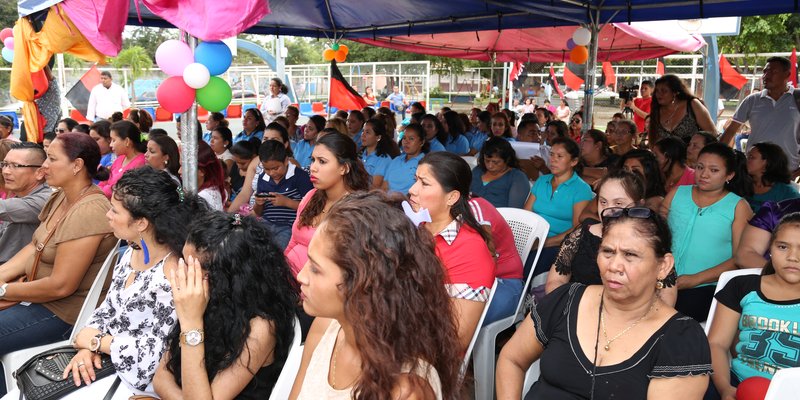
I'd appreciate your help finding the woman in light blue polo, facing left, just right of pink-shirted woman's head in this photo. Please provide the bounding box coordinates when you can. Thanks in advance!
[361,118,400,188]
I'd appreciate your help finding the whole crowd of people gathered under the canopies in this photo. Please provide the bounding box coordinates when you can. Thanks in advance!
[0,57,800,400]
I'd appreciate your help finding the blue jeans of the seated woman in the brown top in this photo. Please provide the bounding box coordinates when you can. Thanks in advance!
[0,304,72,394]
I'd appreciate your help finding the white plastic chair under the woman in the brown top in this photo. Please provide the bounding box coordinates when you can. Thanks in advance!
[0,241,119,390]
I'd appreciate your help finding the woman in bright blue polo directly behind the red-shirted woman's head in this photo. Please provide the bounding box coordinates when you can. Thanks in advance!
[383,124,428,194]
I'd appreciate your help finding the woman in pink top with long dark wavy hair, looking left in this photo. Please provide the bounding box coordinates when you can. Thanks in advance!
[284,133,370,275]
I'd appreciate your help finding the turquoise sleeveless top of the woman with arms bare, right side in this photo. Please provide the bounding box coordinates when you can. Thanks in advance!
[667,185,742,286]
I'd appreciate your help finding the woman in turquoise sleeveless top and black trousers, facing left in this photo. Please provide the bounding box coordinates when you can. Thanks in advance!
[661,143,753,322]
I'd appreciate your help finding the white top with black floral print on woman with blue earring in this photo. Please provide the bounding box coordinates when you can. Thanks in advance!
[87,248,178,395]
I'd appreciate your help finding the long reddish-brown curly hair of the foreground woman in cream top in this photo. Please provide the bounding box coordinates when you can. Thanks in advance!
[320,192,461,399]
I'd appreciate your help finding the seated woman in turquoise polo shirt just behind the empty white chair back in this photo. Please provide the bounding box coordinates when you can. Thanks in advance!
[524,138,594,276]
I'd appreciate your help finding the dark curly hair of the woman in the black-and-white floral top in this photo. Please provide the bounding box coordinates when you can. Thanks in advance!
[113,165,208,255]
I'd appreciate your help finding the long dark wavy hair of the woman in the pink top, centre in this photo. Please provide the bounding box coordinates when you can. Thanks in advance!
[299,132,372,227]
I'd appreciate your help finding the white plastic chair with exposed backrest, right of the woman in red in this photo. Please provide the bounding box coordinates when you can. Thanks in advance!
[472,207,550,399]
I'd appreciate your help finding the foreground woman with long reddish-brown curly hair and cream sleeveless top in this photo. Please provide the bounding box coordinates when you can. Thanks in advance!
[289,192,461,399]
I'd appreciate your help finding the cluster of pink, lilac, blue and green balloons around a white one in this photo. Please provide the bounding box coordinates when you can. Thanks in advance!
[156,40,233,113]
